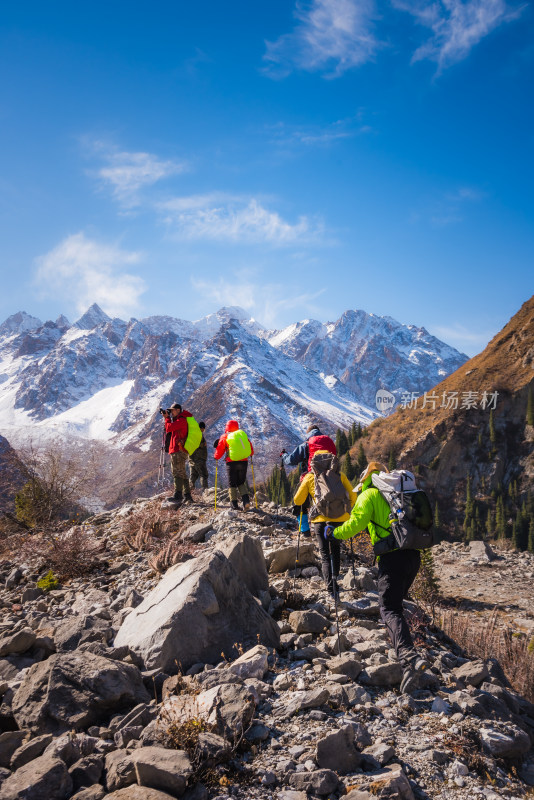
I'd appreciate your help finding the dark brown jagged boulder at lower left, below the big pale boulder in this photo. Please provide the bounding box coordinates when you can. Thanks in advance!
[13,652,150,734]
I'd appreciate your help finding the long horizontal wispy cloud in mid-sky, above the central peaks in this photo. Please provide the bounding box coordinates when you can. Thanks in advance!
[158,193,322,245]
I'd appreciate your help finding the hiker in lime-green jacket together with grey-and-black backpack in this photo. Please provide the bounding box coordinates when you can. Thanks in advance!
[332,461,433,692]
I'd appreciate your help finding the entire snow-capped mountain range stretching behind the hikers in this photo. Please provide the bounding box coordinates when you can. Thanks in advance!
[0,305,466,496]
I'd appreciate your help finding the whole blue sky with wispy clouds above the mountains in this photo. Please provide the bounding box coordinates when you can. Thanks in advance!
[0,0,534,355]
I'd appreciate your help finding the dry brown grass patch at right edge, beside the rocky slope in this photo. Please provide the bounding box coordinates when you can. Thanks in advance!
[439,609,534,702]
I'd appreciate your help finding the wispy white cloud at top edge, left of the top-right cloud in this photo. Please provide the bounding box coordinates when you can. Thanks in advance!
[264,0,379,77]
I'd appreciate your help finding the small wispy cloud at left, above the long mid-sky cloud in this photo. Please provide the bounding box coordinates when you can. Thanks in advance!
[92,142,187,208]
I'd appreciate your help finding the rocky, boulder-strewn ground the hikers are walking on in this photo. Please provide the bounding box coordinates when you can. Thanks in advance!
[0,492,534,800]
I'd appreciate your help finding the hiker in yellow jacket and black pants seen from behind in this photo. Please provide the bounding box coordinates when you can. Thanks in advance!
[293,450,356,599]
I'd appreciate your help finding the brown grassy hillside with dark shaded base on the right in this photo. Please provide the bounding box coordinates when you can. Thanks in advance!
[352,297,534,536]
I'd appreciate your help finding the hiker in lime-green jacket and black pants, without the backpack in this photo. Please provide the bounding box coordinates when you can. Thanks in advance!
[328,461,428,692]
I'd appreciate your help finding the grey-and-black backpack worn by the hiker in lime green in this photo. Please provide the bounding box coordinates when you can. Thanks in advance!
[371,469,436,556]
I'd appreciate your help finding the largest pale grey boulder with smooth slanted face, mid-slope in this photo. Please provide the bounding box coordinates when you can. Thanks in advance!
[115,550,280,673]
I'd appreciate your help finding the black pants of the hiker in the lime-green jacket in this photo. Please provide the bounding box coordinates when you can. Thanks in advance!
[377,550,421,664]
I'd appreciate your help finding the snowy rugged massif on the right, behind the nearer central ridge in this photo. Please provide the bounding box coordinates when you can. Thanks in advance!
[268,311,467,406]
